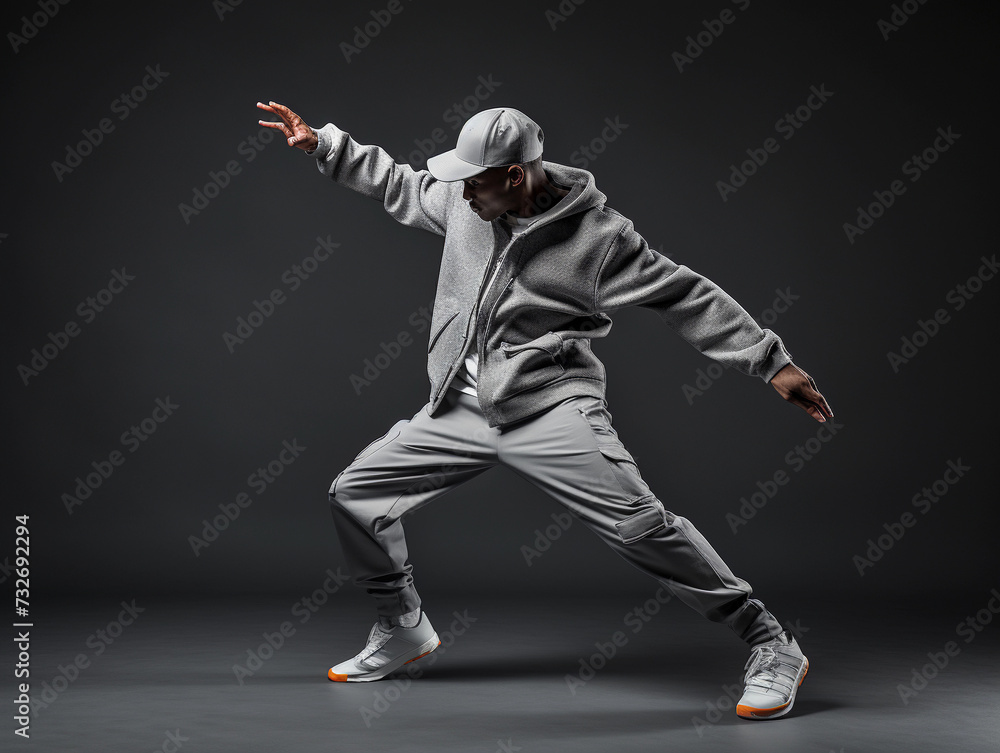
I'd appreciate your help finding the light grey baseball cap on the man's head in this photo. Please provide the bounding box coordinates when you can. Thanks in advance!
[427,107,544,181]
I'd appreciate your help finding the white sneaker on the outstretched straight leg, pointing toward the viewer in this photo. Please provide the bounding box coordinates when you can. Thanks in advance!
[736,631,809,719]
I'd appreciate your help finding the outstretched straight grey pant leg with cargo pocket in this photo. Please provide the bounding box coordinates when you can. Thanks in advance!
[499,396,782,645]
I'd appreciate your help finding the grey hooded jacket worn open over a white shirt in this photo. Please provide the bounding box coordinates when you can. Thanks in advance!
[308,123,792,427]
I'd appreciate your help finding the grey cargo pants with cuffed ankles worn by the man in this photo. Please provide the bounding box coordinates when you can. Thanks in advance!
[330,388,782,645]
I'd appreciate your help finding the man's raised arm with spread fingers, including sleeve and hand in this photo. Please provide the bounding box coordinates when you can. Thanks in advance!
[257,102,455,235]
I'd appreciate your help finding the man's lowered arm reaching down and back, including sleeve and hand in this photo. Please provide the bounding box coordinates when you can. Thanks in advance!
[594,220,833,422]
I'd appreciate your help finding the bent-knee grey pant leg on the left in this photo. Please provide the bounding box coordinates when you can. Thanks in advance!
[329,390,498,617]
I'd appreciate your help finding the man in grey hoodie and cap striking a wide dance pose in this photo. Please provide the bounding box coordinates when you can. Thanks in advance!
[257,102,833,719]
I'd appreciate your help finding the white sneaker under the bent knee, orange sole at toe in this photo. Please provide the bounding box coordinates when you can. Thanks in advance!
[326,610,441,682]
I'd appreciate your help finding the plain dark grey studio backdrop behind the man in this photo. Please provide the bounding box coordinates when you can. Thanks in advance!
[0,0,1000,604]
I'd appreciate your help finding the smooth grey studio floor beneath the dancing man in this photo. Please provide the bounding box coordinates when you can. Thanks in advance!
[9,593,1000,753]
